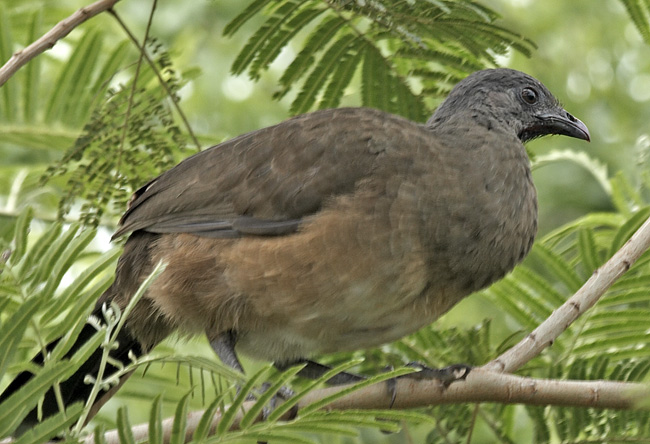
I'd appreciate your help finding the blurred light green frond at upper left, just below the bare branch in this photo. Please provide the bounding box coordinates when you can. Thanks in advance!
[0,16,129,150]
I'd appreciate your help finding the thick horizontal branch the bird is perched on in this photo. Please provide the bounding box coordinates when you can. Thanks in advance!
[90,368,650,444]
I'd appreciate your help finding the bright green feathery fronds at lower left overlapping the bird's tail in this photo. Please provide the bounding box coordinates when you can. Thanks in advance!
[0,210,118,442]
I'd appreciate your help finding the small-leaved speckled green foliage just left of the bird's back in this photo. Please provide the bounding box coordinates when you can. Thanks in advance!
[43,39,190,225]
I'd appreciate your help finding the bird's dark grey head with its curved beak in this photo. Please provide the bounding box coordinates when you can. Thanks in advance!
[427,68,590,142]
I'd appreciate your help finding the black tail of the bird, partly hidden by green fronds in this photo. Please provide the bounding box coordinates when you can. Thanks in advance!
[0,289,144,436]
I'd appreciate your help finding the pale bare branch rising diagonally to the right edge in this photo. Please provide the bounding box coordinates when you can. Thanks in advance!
[483,215,650,373]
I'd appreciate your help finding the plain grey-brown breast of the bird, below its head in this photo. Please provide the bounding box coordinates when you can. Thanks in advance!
[422,138,537,293]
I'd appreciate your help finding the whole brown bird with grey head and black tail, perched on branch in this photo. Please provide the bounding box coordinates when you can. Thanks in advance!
[2,68,590,427]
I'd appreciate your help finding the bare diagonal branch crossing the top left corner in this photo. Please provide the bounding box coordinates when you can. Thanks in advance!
[0,0,119,86]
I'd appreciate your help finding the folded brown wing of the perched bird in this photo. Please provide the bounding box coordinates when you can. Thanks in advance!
[114,108,417,237]
